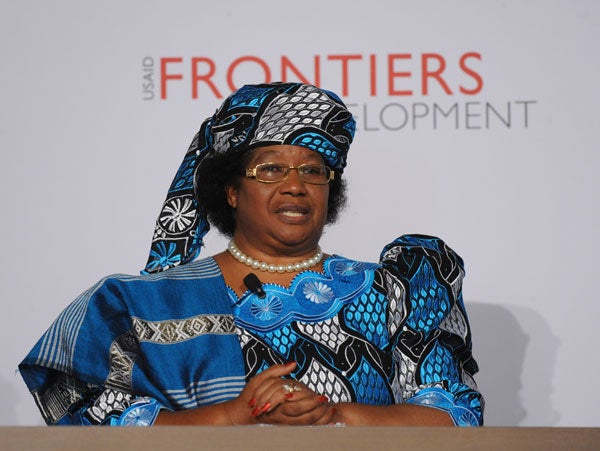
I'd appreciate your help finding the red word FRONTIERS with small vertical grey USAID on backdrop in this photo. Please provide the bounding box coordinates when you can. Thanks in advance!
[142,52,484,100]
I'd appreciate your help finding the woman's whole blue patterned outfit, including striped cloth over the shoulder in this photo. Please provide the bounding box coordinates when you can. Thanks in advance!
[20,235,483,426]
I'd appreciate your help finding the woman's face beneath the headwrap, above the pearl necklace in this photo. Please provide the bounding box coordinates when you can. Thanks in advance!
[227,145,329,258]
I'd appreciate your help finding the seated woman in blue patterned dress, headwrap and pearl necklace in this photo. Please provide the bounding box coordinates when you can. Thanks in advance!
[20,83,483,425]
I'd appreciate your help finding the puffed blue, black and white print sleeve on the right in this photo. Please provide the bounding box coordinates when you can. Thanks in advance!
[380,235,484,426]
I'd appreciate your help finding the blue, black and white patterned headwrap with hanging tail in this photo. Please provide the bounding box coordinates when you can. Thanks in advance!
[142,83,356,273]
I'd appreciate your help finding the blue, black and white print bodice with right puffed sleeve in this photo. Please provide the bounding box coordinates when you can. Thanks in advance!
[229,235,483,426]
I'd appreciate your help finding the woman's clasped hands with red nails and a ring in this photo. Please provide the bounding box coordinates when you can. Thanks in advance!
[229,362,336,425]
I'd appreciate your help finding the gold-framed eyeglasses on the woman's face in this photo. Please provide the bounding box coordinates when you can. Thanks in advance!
[245,163,335,185]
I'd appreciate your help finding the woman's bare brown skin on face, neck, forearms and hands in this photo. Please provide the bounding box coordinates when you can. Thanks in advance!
[155,145,453,426]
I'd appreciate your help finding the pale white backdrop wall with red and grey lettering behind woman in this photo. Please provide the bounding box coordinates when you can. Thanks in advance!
[0,0,600,426]
